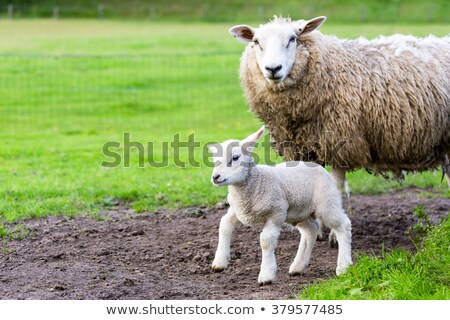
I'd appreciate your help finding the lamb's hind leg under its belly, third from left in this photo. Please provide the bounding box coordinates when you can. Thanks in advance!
[289,219,318,276]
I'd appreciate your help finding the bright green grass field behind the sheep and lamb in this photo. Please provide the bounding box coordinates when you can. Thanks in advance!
[0,20,448,221]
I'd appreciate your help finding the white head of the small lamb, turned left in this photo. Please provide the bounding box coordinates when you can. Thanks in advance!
[208,126,264,187]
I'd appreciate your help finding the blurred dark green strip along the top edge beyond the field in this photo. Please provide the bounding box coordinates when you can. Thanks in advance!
[0,1,450,23]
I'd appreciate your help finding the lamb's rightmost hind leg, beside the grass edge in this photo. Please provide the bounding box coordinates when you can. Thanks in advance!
[330,210,352,275]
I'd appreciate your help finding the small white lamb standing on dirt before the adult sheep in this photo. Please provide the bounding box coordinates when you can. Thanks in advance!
[209,127,352,285]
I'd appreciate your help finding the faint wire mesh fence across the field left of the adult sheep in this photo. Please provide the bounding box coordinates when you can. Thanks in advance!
[0,52,243,132]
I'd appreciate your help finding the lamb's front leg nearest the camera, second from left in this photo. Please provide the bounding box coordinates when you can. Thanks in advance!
[258,220,281,285]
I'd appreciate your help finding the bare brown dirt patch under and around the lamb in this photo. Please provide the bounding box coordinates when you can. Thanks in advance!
[0,190,450,299]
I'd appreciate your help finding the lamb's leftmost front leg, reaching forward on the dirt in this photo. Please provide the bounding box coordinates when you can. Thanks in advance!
[212,207,238,272]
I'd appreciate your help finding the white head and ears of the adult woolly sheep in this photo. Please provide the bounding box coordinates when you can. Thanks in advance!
[229,17,326,84]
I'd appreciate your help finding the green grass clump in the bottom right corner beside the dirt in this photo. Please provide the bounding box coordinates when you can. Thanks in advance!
[298,216,450,300]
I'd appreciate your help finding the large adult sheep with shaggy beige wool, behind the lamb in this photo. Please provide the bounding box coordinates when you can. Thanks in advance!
[230,17,450,190]
